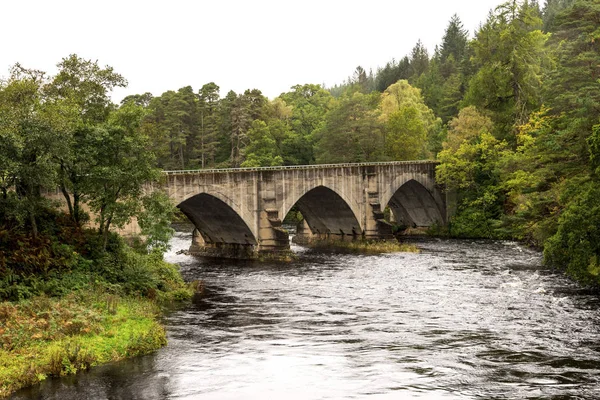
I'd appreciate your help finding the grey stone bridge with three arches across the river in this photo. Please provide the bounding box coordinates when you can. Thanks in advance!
[149,161,446,258]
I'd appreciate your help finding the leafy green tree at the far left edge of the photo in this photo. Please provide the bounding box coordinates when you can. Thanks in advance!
[0,69,72,238]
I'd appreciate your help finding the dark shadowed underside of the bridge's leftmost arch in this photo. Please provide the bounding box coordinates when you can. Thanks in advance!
[177,193,258,245]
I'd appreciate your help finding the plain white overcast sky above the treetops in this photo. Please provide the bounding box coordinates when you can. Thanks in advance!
[0,0,503,101]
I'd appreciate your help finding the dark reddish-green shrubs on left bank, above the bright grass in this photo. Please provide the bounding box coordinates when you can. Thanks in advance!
[0,205,189,300]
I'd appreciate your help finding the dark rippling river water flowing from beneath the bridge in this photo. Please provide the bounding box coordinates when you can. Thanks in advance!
[14,233,600,400]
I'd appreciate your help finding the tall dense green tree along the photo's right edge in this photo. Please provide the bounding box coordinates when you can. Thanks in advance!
[504,0,600,247]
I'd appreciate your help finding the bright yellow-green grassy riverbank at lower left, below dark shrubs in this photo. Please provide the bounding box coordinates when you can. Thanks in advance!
[0,290,175,398]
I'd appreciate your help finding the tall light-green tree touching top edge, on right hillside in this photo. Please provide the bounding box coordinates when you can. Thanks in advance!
[466,0,549,142]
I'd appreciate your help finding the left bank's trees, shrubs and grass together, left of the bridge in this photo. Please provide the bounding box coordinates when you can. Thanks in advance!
[0,57,192,397]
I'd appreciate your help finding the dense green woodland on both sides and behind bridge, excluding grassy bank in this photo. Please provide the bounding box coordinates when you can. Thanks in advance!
[0,0,600,284]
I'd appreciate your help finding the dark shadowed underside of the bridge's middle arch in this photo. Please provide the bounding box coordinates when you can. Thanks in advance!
[294,186,362,237]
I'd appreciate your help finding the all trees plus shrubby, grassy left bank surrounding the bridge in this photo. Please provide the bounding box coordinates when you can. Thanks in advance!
[0,0,600,394]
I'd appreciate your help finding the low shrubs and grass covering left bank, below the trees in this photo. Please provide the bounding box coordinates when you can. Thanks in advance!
[0,219,193,398]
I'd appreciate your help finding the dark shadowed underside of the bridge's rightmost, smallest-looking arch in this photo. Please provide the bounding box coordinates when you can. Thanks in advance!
[387,179,444,227]
